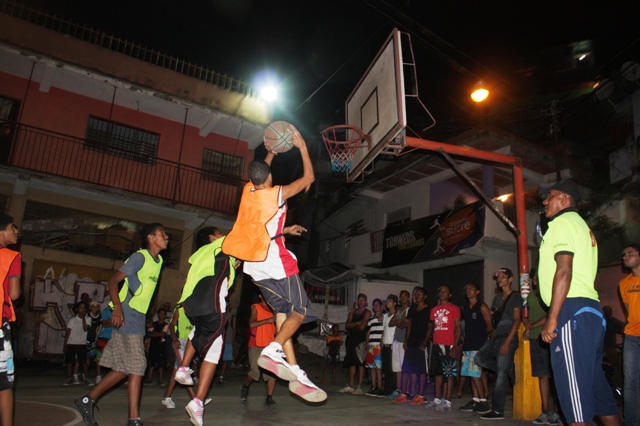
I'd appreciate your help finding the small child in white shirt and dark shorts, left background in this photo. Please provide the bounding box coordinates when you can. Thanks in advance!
[62,302,93,386]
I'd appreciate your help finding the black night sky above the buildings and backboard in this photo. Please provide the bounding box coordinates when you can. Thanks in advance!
[26,0,640,138]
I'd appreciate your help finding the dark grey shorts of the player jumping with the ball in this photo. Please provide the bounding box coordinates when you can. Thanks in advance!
[254,274,318,324]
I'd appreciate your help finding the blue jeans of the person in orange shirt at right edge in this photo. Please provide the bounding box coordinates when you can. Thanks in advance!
[623,334,640,426]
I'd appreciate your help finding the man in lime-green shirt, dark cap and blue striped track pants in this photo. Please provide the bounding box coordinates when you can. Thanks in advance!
[539,181,620,426]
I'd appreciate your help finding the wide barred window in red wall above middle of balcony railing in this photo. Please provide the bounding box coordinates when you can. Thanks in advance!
[85,117,160,164]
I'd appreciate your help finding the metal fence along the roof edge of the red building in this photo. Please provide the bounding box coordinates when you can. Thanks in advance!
[0,0,258,97]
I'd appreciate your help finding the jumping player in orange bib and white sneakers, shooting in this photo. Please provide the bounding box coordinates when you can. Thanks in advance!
[222,125,327,402]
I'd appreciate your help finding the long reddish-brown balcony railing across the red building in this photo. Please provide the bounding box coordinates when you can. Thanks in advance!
[0,122,245,215]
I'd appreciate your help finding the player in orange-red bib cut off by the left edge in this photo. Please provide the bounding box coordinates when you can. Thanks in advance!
[0,215,22,426]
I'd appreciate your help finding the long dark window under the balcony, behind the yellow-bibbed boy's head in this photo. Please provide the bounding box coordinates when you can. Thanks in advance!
[20,201,183,269]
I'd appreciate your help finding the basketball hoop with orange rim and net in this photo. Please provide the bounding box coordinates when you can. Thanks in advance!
[322,124,369,173]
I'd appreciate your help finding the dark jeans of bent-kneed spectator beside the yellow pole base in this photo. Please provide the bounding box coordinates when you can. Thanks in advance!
[474,336,518,414]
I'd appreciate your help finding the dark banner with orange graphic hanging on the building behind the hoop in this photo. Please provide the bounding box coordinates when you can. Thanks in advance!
[382,201,486,267]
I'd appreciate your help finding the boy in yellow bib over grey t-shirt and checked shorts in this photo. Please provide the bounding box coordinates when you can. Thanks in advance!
[74,223,169,426]
